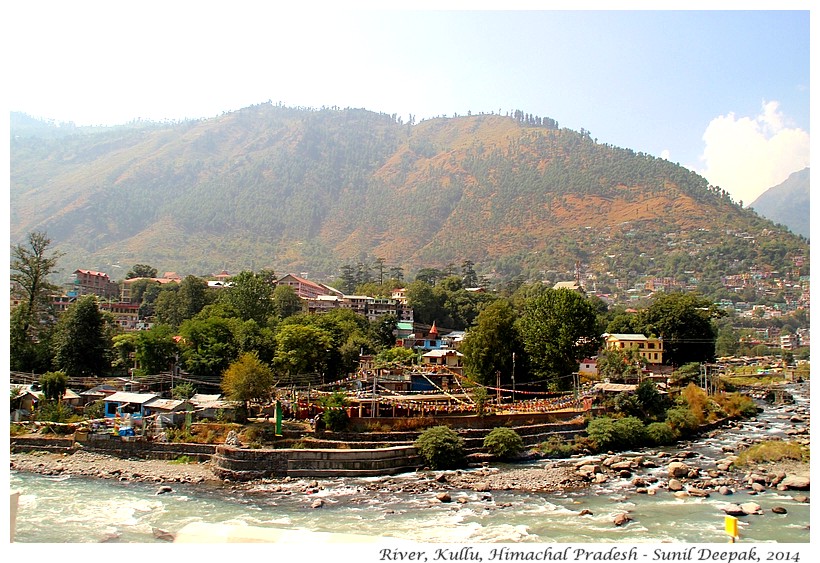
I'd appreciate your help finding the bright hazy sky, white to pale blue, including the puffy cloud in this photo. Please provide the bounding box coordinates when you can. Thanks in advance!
[2,0,810,204]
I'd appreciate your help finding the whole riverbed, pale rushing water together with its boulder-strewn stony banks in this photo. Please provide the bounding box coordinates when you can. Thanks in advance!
[10,383,810,543]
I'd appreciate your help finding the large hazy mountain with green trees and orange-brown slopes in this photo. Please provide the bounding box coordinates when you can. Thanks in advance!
[10,103,809,282]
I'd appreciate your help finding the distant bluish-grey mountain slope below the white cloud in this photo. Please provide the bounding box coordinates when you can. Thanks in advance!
[749,168,811,238]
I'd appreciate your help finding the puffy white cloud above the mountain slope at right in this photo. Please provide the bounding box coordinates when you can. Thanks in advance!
[690,101,810,206]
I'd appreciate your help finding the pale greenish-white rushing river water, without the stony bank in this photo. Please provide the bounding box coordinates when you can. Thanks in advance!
[10,384,810,543]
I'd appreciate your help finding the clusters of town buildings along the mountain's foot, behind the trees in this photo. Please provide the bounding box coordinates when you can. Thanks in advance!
[16,252,811,350]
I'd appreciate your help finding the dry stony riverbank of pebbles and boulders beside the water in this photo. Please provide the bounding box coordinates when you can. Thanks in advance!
[10,382,810,500]
